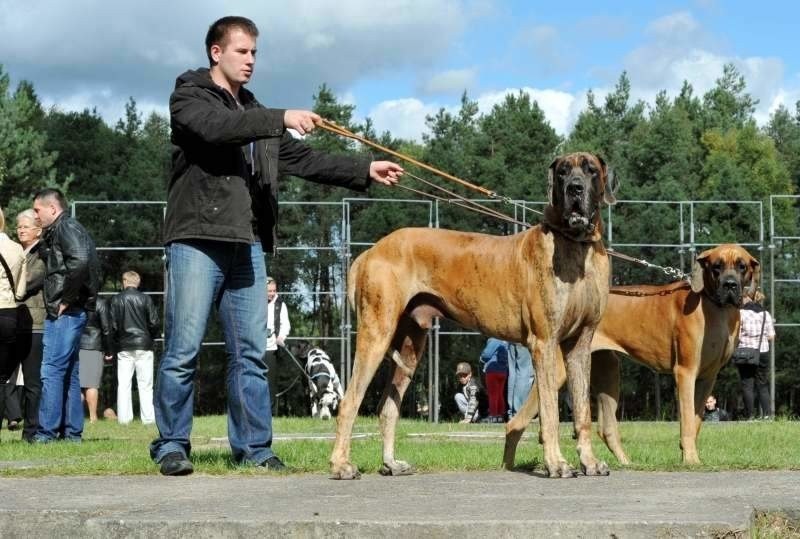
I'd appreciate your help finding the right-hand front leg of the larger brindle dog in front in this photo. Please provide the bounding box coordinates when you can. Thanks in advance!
[562,326,608,475]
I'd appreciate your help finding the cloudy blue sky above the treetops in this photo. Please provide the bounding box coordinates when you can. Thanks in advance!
[0,0,800,139]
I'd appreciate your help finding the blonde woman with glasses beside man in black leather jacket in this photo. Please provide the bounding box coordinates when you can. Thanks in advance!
[14,209,46,442]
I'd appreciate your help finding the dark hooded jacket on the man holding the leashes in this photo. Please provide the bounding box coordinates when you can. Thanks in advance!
[164,69,370,251]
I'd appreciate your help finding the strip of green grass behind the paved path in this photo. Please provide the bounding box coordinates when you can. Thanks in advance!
[0,416,800,477]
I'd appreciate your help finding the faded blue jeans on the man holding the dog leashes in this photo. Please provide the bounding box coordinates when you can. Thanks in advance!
[150,240,273,464]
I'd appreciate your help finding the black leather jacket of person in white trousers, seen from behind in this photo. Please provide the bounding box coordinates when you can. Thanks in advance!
[111,286,161,352]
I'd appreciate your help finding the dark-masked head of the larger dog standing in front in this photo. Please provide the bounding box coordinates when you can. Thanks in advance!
[545,152,617,241]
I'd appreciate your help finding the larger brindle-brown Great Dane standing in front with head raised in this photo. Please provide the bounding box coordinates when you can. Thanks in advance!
[330,153,615,479]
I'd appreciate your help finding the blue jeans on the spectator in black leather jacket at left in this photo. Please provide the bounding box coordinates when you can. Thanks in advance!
[34,311,86,442]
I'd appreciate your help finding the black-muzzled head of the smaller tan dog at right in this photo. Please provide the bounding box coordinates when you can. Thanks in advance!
[691,243,761,307]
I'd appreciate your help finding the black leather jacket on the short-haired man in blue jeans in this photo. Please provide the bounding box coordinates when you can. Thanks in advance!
[39,212,100,317]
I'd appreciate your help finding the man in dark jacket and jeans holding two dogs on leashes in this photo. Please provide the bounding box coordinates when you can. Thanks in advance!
[150,13,402,475]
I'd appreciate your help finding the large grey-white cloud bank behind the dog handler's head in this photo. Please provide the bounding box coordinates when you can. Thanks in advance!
[0,0,470,121]
